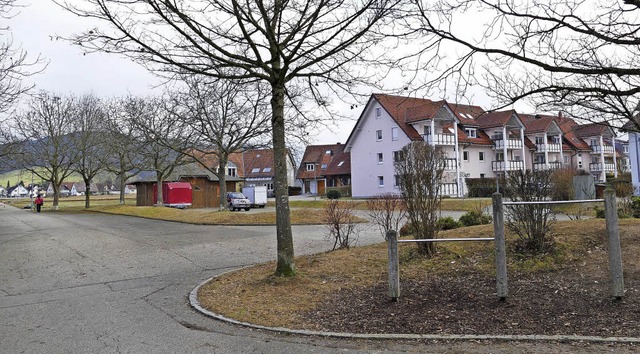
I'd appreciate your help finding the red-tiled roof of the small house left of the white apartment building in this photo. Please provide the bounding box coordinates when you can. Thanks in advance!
[296,144,351,179]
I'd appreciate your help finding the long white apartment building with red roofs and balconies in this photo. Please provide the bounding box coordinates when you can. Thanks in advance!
[344,94,632,197]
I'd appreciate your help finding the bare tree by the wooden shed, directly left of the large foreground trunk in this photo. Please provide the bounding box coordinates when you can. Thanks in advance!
[169,75,271,209]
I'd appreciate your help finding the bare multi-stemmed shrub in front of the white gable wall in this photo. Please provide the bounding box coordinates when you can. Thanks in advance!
[394,141,446,257]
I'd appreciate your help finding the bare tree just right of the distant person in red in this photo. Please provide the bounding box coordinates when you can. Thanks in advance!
[12,92,78,209]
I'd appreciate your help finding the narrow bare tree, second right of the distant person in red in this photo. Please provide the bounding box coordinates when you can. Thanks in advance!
[70,94,105,208]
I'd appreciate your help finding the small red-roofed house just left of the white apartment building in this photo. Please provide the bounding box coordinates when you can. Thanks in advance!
[296,143,352,195]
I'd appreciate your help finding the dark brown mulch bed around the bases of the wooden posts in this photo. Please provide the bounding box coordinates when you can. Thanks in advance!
[304,258,640,337]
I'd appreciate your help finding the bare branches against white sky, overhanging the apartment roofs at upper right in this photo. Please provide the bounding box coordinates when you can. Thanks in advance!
[407,0,640,129]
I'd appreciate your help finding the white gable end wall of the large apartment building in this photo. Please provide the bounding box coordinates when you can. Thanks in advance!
[350,100,411,198]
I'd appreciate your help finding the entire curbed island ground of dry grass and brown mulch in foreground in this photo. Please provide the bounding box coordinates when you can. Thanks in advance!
[199,219,640,337]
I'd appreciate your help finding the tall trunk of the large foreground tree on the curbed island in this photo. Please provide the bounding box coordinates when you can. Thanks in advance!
[271,80,295,277]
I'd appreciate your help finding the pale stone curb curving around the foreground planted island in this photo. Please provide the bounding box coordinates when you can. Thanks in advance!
[189,269,640,343]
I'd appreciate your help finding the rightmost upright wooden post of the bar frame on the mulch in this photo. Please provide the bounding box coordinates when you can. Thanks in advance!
[604,188,624,299]
